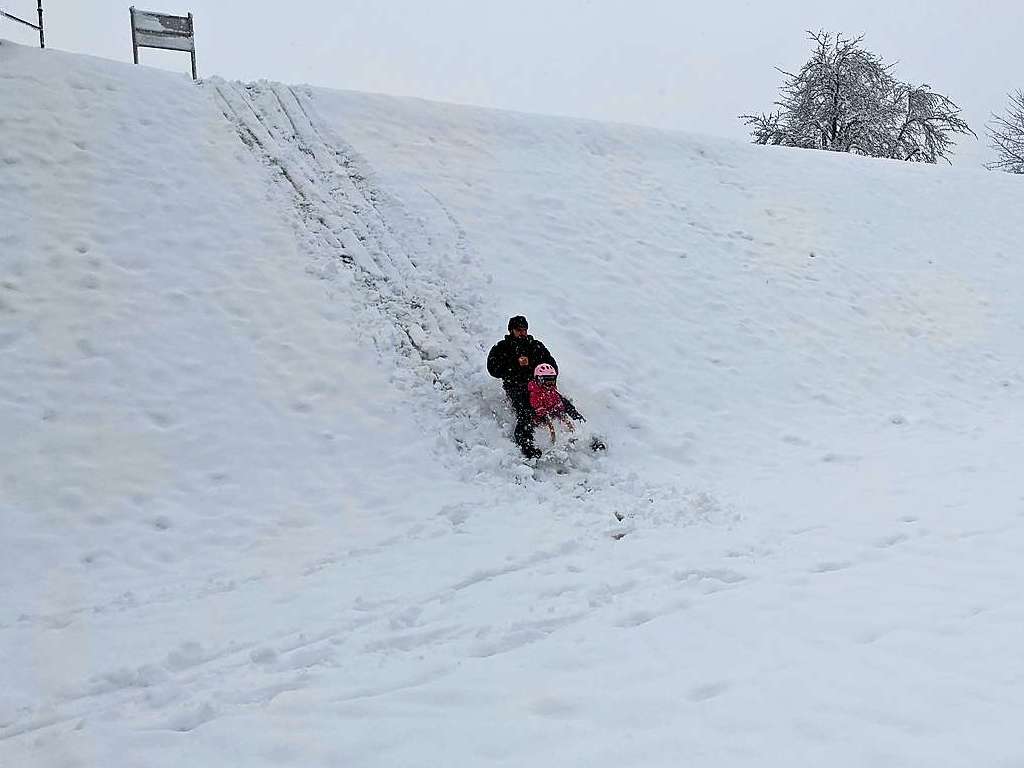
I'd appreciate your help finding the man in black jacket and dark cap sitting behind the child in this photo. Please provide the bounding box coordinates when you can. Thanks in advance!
[487,314,558,459]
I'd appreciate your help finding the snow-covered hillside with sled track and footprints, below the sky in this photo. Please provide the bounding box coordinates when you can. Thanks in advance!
[6,42,1024,768]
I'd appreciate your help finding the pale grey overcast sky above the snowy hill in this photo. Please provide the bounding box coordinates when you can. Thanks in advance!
[0,0,1024,164]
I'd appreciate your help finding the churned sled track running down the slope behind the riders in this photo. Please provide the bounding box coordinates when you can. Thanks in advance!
[212,80,497,460]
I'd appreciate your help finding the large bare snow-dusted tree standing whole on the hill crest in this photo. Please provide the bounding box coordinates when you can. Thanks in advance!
[741,32,974,163]
